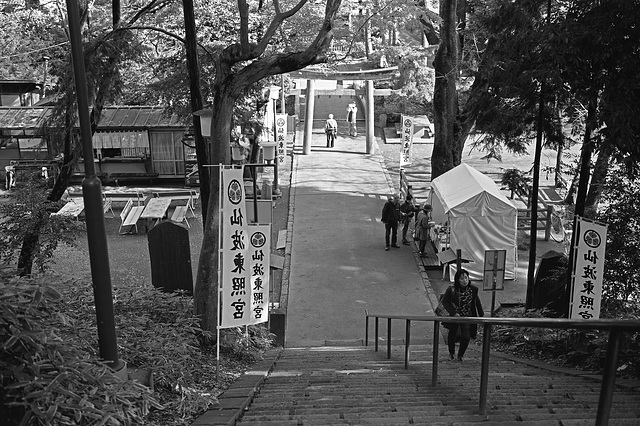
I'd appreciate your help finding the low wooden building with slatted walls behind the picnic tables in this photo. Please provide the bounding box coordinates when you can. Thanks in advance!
[0,106,195,183]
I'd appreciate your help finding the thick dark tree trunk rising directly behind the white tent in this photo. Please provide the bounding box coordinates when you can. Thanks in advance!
[431,1,462,180]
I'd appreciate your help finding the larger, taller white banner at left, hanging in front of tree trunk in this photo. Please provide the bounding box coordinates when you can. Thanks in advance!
[220,167,251,328]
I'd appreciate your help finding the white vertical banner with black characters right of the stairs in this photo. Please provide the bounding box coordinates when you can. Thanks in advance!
[569,216,607,320]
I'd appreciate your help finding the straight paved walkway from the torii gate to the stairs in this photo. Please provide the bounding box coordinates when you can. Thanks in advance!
[281,133,433,347]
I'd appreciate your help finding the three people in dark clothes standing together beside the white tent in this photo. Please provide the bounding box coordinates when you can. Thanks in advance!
[382,194,434,257]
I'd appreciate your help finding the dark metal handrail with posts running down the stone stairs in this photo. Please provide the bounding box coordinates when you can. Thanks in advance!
[365,310,640,426]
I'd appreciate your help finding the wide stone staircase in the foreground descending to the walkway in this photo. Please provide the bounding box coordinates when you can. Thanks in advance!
[228,343,640,426]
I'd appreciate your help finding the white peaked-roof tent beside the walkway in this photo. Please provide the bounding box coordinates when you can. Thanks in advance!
[431,163,518,281]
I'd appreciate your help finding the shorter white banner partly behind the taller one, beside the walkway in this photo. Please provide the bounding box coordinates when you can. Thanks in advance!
[249,224,271,324]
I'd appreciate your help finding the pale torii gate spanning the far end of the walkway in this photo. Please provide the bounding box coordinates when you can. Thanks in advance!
[290,67,398,155]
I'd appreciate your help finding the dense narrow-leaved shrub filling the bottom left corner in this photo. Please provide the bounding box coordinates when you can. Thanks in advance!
[0,269,160,425]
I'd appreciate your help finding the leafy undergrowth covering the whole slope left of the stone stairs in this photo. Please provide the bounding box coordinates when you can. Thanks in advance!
[0,269,270,426]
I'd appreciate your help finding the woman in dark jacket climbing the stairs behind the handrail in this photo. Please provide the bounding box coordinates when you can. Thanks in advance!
[442,269,484,362]
